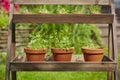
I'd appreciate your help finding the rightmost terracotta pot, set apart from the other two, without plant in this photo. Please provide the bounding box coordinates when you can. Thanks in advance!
[82,47,104,62]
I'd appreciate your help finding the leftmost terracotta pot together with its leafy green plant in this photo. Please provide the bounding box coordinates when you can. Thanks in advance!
[24,31,47,61]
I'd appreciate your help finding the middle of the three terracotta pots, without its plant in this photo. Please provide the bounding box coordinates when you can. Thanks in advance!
[51,48,74,61]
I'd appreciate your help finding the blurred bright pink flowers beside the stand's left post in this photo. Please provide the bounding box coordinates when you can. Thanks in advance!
[0,0,19,12]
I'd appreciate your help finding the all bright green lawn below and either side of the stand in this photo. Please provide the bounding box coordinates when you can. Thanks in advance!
[0,53,120,80]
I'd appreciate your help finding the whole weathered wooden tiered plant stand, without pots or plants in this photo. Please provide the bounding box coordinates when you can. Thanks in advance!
[5,0,118,80]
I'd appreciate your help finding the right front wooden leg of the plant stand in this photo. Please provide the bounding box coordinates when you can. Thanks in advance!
[111,0,118,80]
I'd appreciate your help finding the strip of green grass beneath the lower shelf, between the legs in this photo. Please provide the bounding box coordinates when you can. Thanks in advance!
[18,72,106,80]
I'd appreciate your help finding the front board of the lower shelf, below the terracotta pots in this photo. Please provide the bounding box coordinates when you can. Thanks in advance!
[10,62,116,71]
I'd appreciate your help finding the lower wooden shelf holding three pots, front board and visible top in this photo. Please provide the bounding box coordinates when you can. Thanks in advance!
[10,55,117,71]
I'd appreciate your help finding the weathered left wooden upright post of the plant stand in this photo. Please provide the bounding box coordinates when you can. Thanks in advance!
[5,0,15,80]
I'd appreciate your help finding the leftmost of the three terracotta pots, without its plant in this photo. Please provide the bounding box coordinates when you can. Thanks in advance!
[24,47,47,61]
